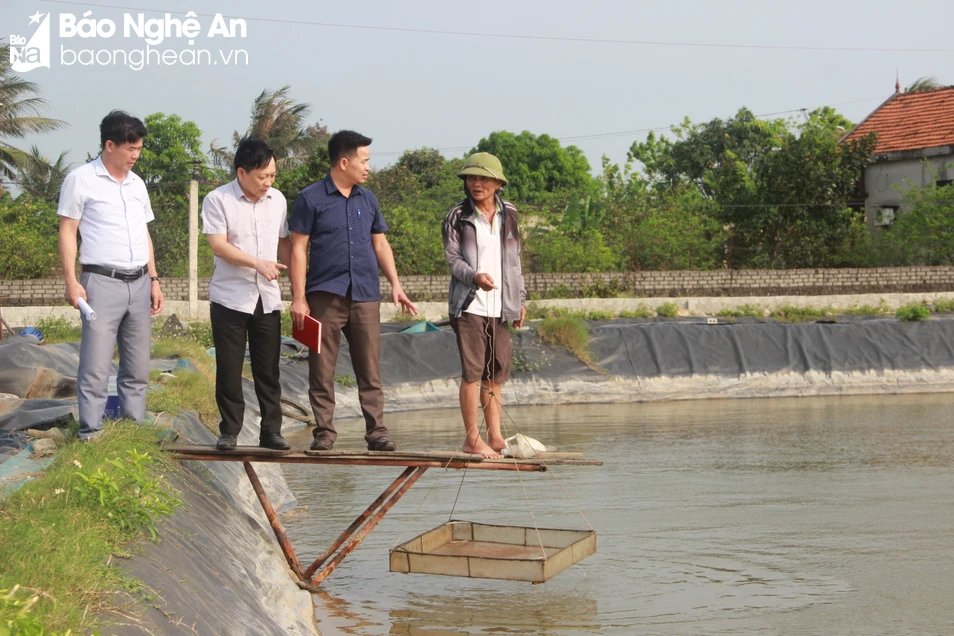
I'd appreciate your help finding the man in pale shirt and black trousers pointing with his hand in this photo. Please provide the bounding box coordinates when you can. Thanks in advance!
[202,139,291,451]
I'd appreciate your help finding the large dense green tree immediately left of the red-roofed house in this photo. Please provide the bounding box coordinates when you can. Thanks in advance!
[630,108,873,267]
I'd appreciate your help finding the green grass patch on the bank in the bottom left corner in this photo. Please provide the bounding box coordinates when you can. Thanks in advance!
[0,422,179,634]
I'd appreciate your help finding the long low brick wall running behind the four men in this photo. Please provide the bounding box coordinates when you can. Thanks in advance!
[0,267,954,307]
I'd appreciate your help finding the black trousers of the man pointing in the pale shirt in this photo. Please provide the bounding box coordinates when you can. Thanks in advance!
[209,298,282,438]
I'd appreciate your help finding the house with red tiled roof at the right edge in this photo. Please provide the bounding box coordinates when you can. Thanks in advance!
[842,86,954,228]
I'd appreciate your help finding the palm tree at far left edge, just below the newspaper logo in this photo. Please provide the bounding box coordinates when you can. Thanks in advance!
[0,42,66,194]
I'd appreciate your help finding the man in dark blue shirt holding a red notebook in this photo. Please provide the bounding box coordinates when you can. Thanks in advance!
[288,130,417,451]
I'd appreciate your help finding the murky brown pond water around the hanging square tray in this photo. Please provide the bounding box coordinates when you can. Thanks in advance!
[283,394,954,636]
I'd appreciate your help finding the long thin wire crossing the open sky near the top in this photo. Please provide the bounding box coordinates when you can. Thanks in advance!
[41,0,954,53]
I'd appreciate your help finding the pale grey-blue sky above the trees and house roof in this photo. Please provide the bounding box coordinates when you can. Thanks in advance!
[0,0,954,176]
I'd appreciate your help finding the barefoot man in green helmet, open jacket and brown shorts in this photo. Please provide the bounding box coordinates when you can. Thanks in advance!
[442,152,527,458]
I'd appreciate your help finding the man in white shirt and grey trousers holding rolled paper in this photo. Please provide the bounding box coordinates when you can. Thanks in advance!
[57,110,164,440]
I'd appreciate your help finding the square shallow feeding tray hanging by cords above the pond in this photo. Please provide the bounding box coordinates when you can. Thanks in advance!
[391,521,596,583]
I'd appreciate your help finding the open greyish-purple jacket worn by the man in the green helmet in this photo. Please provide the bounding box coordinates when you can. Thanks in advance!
[441,197,527,322]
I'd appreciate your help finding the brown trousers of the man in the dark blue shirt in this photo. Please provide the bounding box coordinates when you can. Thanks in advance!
[307,292,388,442]
